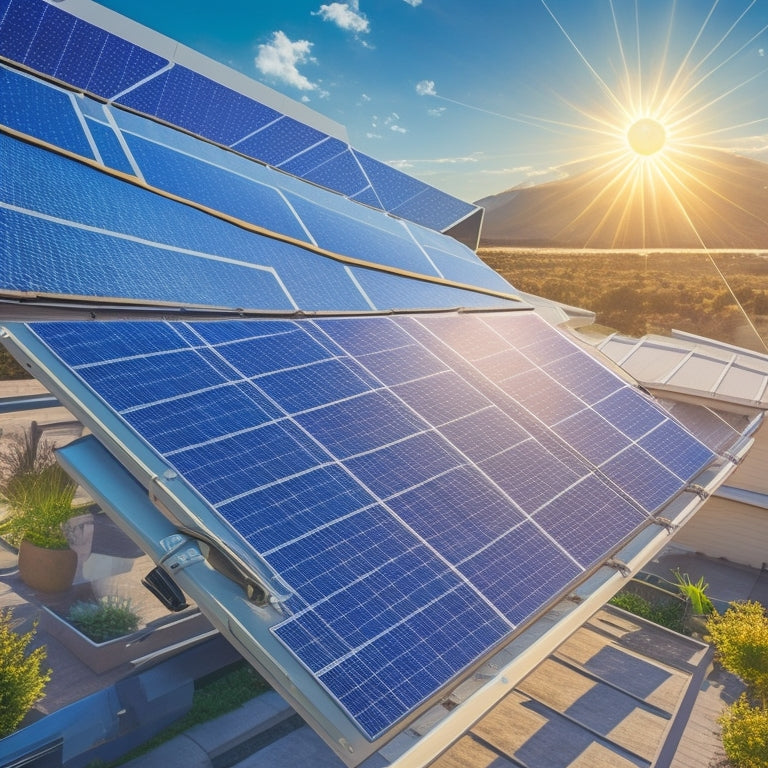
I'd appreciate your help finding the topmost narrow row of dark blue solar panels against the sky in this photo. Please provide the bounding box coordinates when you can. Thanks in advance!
[0,0,479,237]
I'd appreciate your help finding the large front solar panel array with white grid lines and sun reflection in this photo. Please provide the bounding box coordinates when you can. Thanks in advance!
[24,312,714,740]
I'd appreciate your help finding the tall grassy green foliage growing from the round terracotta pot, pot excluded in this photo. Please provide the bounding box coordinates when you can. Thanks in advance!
[0,424,77,549]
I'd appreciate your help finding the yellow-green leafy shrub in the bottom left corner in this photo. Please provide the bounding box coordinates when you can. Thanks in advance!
[0,608,51,738]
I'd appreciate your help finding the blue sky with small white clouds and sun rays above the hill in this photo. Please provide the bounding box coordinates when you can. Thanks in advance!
[91,0,768,201]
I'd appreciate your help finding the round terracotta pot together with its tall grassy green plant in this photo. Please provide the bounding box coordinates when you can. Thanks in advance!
[0,430,79,592]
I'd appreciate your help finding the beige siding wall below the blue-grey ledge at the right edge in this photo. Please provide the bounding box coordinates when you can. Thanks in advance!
[674,496,768,568]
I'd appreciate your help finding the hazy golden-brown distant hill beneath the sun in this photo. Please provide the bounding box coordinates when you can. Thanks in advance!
[477,150,768,249]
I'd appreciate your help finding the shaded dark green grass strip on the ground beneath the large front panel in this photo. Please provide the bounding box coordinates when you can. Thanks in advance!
[88,661,269,768]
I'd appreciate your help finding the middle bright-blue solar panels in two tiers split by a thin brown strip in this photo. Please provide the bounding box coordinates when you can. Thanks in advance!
[0,60,511,310]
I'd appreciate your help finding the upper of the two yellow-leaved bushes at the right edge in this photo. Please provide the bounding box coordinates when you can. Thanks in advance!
[707,601,768,709]
